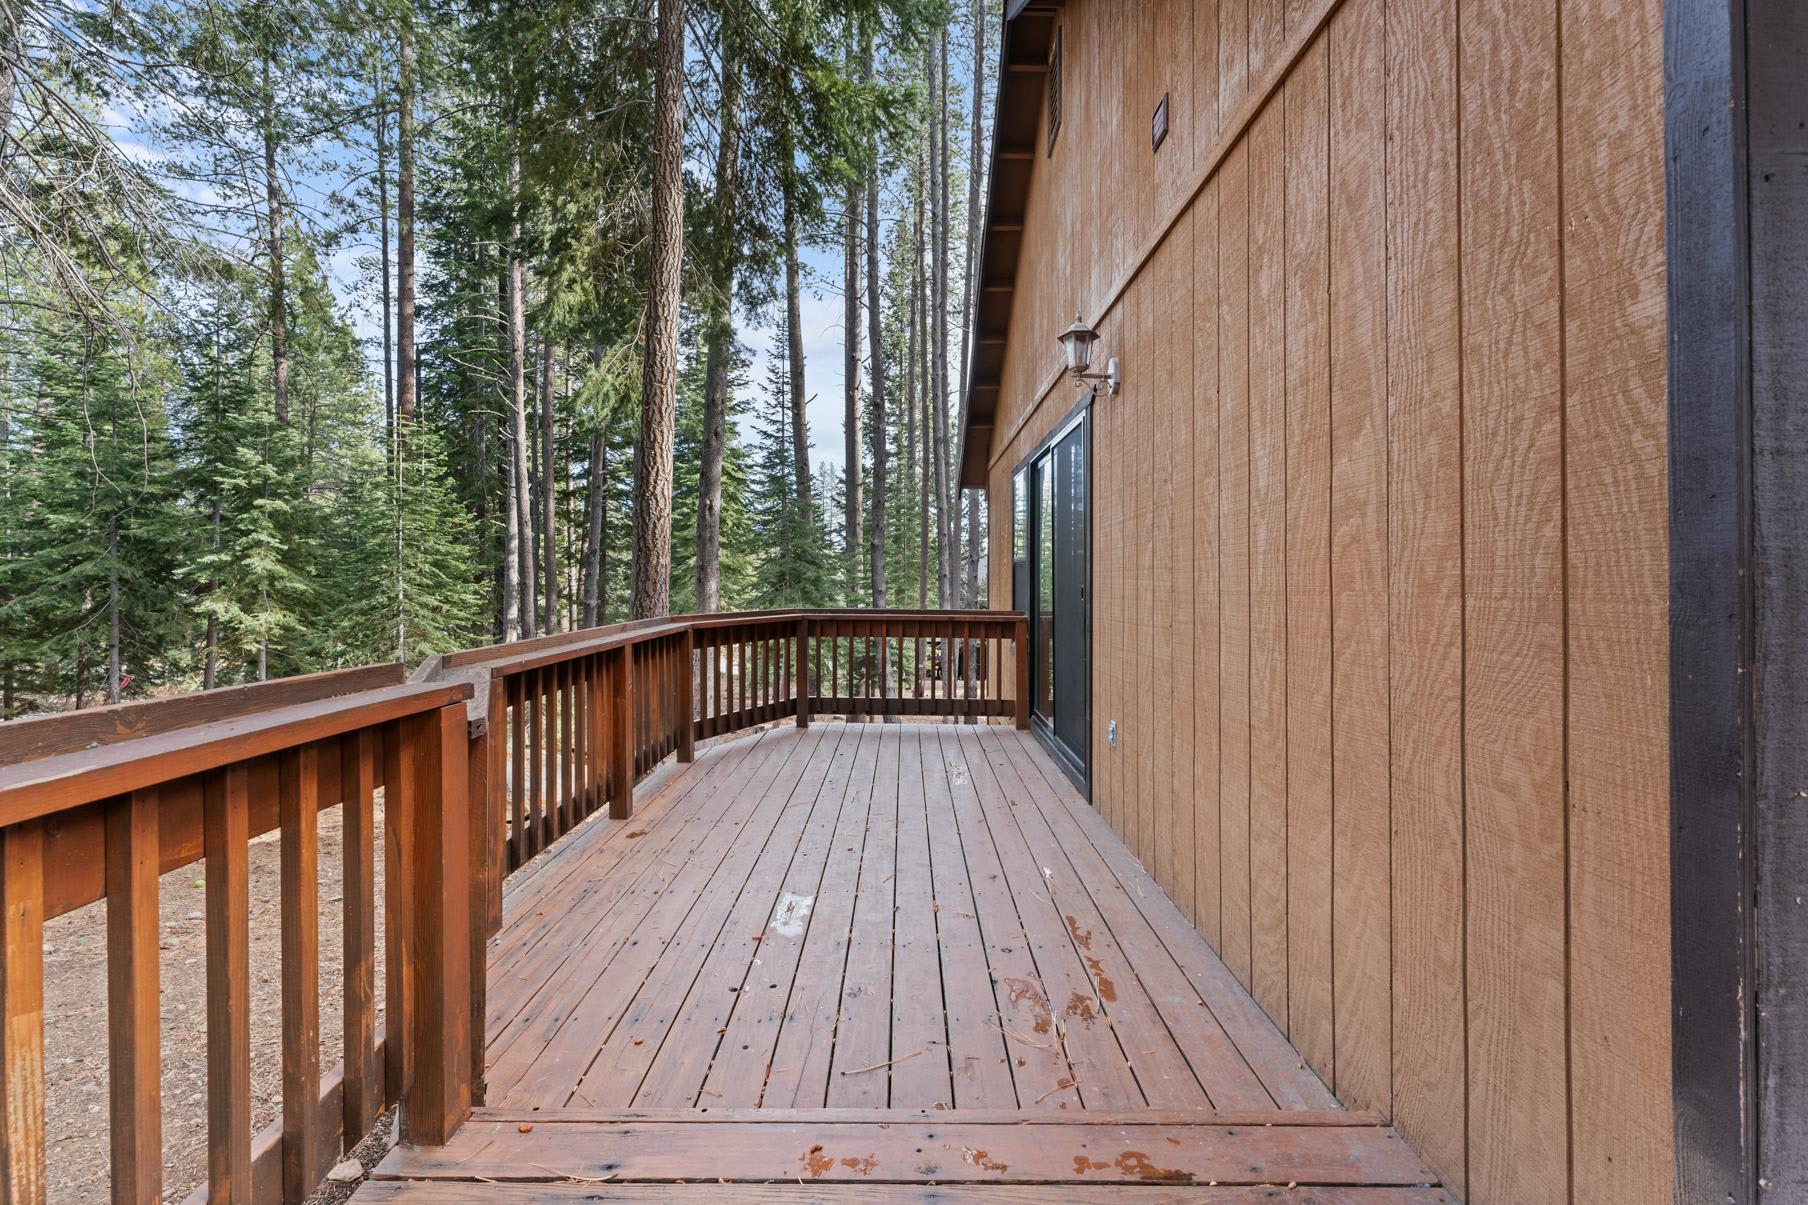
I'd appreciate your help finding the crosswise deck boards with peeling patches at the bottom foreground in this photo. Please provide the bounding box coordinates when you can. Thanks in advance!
[356,1111,1448,1203]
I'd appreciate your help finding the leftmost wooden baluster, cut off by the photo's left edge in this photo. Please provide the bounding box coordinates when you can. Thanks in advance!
[0,820,47,1205]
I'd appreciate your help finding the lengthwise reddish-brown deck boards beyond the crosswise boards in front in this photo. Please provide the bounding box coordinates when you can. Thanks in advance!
[488,724,1334,1109]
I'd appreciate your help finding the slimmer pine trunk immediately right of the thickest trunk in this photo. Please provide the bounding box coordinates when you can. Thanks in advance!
[696,42,741,613]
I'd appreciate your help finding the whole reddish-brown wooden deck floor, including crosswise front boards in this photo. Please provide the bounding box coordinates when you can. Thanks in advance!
[356,724,1450,1205]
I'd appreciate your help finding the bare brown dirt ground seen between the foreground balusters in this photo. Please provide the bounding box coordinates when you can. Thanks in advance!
[43,792,389,1205]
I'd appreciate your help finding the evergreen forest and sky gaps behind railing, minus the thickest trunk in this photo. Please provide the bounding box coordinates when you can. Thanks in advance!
[0,0,998,716]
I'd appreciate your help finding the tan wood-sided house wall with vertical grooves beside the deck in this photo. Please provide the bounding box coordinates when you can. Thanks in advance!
[987,0,1674,1203]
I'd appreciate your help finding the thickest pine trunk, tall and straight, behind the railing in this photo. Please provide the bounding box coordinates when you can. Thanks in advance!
[631,0,685,619]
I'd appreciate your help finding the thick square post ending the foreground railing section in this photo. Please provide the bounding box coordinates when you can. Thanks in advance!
[403,704,474,1147]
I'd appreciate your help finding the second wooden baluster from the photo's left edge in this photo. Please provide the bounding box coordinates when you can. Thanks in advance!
[105,791,163,1205]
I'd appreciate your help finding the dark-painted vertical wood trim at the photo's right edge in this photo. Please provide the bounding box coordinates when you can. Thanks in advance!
[1663,0,1808,1205]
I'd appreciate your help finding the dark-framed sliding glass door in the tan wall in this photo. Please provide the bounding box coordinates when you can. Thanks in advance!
[1027,414,1092,780]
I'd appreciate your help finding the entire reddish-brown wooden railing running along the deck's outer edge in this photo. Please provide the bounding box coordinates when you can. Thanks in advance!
[0,610,1029,1201]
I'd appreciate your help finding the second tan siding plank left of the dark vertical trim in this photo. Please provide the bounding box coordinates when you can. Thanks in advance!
[1459,0,1569,1205]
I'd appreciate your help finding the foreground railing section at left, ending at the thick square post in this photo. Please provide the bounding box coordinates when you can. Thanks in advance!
[0,666,481,1203]
